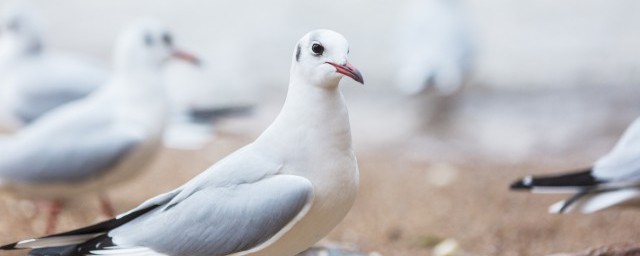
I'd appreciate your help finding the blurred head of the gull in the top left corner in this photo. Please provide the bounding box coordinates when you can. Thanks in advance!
[0,1,42,56]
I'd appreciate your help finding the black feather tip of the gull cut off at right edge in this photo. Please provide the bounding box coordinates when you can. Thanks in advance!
[511,168,601,193]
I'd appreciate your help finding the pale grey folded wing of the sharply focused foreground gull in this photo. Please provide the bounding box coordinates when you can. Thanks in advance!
[107,175,313,256]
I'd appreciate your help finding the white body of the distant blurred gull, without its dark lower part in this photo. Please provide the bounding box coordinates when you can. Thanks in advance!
[394,0,473,95]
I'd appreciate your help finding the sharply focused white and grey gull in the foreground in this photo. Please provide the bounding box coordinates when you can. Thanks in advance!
[0,30,363,256]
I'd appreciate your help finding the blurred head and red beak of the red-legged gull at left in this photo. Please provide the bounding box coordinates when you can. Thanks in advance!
[114,20,200,72]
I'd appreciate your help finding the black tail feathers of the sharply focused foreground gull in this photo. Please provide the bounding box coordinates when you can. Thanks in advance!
[0,205,158,256]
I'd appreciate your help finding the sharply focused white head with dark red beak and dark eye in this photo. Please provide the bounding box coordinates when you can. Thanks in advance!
[291,29,364,87]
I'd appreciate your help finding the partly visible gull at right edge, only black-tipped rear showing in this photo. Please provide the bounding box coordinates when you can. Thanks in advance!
[511,118,640,214]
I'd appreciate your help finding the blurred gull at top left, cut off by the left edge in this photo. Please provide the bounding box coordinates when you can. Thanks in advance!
[0,1,109,131]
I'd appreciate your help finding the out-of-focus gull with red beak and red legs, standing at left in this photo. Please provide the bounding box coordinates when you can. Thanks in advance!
[0,20,197,233]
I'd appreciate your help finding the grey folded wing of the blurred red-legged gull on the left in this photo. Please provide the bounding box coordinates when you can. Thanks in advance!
[0,124,144,183]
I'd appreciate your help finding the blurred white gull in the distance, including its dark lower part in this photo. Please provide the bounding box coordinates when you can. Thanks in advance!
[393,0,474,137]
